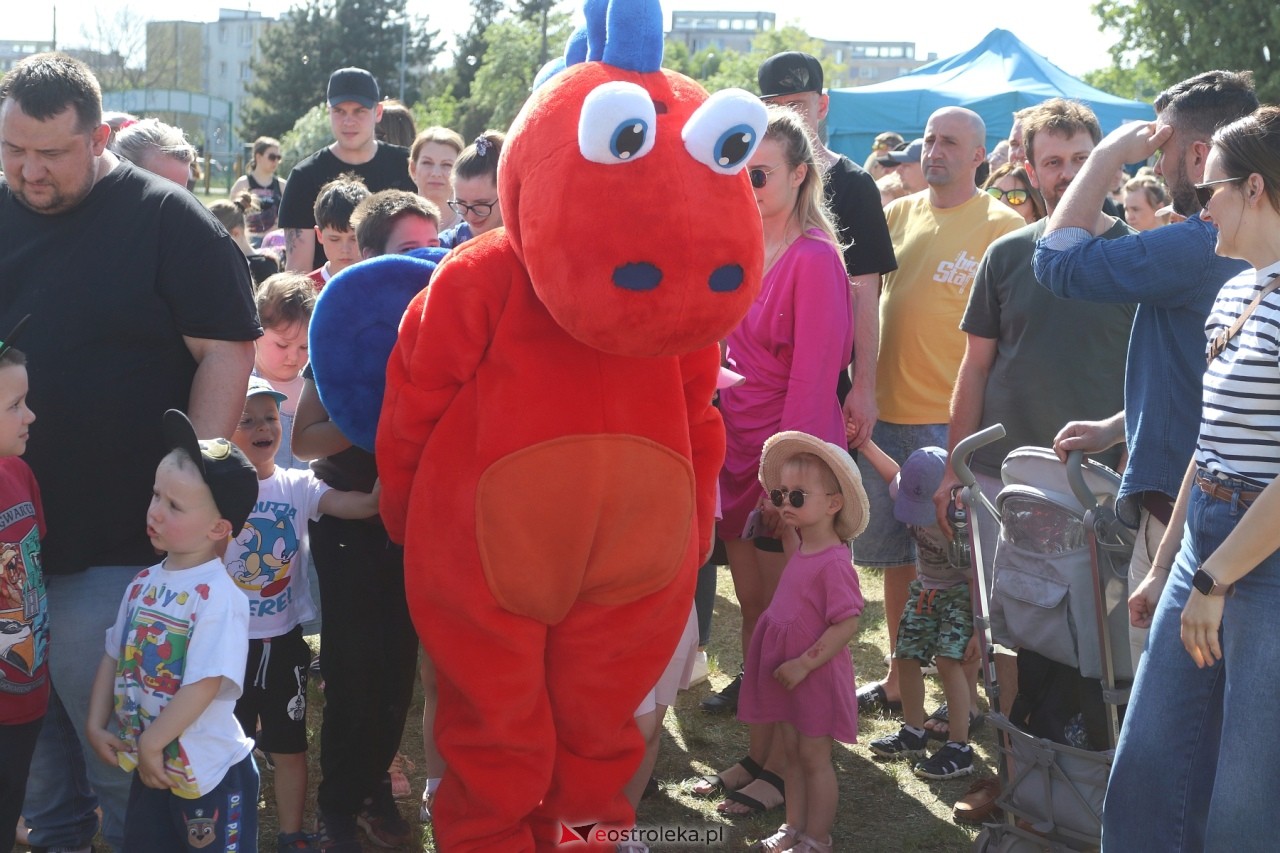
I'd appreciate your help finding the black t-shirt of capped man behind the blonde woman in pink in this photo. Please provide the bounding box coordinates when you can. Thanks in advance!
[823,155,897,402]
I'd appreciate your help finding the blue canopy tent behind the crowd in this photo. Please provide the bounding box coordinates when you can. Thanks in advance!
[827,29,1155,164]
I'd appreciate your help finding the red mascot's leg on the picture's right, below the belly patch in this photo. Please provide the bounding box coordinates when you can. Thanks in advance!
[534,571,694,850]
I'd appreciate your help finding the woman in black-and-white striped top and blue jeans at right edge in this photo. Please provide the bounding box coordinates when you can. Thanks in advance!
[1102,106,1280,850]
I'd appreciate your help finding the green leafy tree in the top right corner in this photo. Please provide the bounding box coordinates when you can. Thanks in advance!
[1093,0,1280,102]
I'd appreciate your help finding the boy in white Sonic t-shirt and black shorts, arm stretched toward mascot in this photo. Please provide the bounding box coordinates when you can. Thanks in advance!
[225,377,378,850]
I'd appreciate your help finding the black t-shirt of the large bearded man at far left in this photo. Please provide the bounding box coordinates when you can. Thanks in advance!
[0,163,262,574]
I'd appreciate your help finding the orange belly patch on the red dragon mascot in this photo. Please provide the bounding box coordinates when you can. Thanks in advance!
[476,435,695,625]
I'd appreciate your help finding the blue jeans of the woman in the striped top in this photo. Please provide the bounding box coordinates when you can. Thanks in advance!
[1102,487,1280,853]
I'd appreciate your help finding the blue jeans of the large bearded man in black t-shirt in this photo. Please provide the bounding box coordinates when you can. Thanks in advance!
[22,566,141,850]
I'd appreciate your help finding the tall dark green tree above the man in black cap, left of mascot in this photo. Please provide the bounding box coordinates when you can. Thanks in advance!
[241,0,440,138]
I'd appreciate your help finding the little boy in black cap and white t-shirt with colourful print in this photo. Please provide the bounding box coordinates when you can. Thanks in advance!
[86,409,259,853]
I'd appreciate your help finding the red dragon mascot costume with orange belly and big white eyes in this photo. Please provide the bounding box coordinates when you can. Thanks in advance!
[376,0,767,853]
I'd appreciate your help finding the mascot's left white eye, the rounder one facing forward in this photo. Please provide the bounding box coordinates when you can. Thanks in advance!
[577,81,658,165]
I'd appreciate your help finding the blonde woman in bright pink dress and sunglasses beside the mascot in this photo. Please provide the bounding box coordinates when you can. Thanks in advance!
[695,106,856,815]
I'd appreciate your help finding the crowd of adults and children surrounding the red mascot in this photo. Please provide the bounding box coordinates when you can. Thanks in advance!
[0,34,1280,853]
